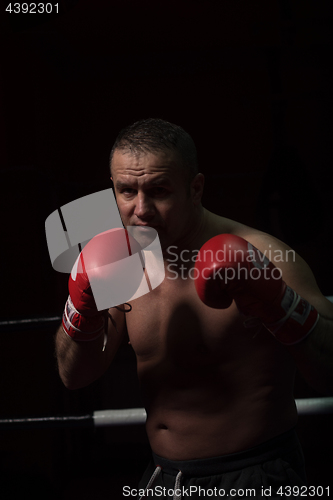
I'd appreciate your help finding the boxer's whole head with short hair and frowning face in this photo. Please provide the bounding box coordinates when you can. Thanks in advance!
[110,119,203,248]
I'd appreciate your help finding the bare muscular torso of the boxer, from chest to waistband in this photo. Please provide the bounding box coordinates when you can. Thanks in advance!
[126,213,297,460]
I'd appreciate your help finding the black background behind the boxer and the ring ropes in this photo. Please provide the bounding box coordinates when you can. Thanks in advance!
[0,0,333,500]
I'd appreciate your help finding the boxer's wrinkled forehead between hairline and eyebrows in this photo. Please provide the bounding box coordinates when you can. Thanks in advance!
[111,150,184,180]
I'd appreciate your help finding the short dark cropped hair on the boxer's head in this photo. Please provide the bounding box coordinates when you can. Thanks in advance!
[110,118,198,180]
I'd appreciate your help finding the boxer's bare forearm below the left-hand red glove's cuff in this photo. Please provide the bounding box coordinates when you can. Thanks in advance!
[55,326,108,389]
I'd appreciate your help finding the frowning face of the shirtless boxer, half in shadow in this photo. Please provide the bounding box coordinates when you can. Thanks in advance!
[111,150,203,249]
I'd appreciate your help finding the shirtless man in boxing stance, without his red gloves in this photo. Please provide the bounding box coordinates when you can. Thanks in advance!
[56,119,333,498]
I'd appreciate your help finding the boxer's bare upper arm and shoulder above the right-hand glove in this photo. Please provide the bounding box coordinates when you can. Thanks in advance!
[245,233,333,319]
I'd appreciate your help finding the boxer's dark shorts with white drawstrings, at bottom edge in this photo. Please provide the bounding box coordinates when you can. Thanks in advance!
[138,429,306,500]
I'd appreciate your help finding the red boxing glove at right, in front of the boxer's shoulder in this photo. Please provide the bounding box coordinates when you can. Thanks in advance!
[195,234,319,345]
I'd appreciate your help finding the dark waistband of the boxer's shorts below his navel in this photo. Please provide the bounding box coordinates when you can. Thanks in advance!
[153,428,300,477]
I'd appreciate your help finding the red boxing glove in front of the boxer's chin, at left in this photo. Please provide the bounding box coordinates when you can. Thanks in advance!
[62,229,141,341]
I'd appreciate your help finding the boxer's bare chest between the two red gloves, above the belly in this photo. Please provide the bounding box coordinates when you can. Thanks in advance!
[126,279,254,366]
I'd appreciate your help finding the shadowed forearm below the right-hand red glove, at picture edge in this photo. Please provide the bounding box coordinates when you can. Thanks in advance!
[287,317,333,396]
